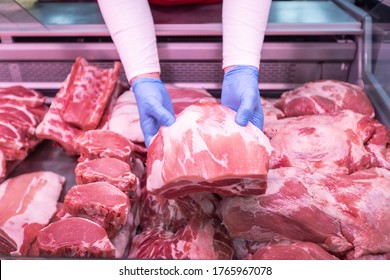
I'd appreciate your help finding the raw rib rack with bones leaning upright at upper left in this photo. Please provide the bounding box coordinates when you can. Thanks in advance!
[36,58,122,155]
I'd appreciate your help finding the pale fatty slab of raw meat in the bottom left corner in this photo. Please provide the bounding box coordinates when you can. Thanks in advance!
[0,172,65,255]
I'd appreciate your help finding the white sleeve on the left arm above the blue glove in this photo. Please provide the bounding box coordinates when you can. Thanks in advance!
[98,0,160,81]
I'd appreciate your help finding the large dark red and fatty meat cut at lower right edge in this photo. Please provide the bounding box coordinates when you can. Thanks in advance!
[220,168,390,258]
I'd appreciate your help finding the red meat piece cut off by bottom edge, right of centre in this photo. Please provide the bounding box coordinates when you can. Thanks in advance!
[245,242,338,260]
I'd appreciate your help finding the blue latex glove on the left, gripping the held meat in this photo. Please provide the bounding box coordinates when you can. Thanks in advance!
[132,78,175,147]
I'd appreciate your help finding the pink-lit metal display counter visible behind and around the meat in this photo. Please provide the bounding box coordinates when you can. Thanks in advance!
[0,1,390,260]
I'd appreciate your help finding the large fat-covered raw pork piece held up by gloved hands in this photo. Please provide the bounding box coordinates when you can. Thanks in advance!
[146,101,272,198]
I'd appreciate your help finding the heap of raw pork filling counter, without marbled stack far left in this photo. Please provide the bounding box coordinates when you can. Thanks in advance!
[0,58,390,260]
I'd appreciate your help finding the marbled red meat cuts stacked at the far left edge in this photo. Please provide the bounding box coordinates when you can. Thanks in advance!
[0,86,47,182]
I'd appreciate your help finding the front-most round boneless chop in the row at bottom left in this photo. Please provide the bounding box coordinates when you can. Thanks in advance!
[36,217,115,258]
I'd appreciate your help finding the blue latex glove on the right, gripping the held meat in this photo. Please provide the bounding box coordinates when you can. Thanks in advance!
[221,65,264,130]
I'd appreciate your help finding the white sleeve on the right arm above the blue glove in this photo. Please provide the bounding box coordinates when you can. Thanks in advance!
[222,0,271,68]
